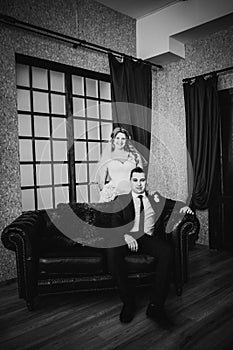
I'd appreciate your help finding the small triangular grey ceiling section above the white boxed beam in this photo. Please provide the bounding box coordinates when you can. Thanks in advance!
[96,0,182,19]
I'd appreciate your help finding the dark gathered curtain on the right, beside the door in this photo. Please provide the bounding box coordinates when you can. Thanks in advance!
[183,74,220,209]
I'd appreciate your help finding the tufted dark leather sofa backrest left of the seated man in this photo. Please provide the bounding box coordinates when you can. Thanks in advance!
[39,202,117,247]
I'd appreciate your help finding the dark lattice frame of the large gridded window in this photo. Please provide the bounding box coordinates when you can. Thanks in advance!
[15,54,113,210]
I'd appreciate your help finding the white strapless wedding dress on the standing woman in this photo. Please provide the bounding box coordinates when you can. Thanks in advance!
[100,157,136,202]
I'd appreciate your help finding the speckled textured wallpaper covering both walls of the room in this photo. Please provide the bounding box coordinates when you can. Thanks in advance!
[0,0,233,281]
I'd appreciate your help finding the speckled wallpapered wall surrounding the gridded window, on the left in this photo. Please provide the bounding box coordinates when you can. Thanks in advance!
[0,0,136,281]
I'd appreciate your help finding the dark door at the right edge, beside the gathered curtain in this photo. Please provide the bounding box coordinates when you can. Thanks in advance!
[208,89,233,252]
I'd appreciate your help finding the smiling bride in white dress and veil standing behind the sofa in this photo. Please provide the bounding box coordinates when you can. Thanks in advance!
[94,127,146,202]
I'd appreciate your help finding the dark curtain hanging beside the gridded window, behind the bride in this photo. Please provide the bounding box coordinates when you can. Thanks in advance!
[108,54,152,161]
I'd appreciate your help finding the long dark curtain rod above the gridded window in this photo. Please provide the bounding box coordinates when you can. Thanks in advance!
[0,13,163,69]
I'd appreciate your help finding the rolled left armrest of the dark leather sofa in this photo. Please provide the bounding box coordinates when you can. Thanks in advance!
[1,210,44,302]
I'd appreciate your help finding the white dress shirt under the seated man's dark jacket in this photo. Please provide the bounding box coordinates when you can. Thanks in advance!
[130,192,155,235]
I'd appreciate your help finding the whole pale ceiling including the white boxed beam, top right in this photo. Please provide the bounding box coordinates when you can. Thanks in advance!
[95,0,233,65]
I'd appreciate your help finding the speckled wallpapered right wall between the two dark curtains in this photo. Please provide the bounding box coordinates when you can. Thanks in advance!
[149,26,233,244]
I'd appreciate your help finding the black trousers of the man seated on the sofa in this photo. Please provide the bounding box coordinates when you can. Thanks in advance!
[107,232,173,307]
